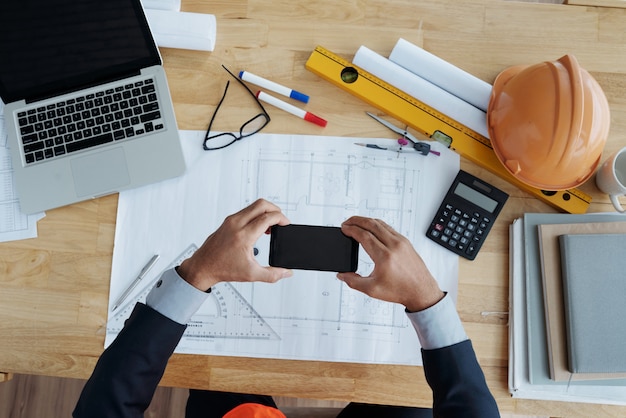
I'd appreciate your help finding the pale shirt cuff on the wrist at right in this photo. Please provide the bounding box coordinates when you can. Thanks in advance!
[407,294,468,350]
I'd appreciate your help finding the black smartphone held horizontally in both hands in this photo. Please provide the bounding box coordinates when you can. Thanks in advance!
[269,224,359,273]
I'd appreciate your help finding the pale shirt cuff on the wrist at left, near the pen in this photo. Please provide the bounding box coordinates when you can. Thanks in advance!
[146,269,209,325]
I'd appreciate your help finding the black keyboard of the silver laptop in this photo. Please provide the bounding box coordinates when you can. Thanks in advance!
[17,78,164,164]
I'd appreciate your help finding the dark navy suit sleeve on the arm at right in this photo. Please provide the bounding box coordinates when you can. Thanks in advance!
[422,340,500,418]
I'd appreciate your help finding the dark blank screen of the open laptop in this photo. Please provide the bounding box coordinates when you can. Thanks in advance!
[0,0,161,103]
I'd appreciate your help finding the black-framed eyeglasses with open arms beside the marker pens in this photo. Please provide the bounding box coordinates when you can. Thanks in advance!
[202,65,270,151]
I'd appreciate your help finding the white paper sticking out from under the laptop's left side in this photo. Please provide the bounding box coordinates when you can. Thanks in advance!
[0,101,45,242]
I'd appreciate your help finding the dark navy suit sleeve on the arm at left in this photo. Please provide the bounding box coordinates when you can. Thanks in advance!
[73,303,186,418]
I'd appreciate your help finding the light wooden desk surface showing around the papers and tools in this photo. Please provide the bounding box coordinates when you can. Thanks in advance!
[0,0,626,416]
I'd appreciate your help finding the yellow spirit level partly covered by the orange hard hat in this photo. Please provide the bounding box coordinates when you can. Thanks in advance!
[305,46,591,213]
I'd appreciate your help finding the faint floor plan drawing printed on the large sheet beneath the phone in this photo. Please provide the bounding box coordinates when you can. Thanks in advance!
[232,148,420,341]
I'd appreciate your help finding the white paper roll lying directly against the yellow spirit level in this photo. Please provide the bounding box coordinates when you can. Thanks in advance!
[353,46,489,138]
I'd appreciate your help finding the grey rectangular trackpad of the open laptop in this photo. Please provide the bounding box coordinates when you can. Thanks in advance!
[71,148,130,197]
